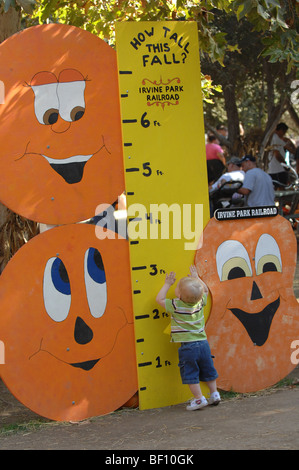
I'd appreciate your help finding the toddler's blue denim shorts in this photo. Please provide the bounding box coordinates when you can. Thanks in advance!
[179,340,218,384]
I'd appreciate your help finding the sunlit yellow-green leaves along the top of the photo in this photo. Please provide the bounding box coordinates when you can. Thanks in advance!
[11,0,299,71]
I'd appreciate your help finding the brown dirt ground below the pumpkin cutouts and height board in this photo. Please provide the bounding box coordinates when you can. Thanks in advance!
[0,232,299,452]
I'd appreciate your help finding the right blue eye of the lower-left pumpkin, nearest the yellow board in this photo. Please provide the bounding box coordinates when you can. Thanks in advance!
[84,248,107,318]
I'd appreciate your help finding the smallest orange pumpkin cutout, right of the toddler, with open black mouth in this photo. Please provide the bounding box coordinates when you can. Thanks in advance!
[195,216,299,392]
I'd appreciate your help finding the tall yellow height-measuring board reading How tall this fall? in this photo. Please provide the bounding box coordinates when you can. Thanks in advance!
[116,22,209,409]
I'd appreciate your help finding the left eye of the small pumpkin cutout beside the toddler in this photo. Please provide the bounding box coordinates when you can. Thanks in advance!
[216,240,252,281]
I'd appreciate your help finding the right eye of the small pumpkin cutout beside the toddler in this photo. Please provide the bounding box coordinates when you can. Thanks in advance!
[255,233,282,275]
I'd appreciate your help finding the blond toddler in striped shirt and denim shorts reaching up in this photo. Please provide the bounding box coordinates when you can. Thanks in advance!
[156,266,220,410]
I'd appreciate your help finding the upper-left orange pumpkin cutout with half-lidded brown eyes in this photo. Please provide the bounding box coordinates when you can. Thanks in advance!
[0,24,124,224]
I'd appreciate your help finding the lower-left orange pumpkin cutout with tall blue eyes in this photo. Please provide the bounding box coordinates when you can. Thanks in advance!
[0,224,138,421]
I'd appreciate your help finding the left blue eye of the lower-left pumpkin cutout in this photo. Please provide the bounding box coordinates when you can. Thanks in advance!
[43,257,71,322]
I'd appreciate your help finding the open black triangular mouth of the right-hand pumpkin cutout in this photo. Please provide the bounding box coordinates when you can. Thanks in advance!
[229,297,280,346]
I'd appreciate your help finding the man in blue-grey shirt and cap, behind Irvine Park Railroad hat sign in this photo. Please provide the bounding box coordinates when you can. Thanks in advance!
[238,155,275,207]
